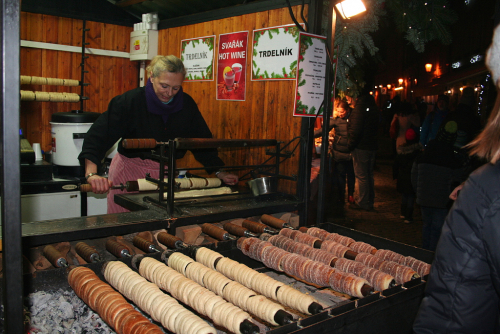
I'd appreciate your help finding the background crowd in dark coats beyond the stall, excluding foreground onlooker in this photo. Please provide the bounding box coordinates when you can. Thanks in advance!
[315,81,484,251]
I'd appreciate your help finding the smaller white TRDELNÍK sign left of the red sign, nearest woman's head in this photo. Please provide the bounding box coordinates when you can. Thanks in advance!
[181,36,215,81]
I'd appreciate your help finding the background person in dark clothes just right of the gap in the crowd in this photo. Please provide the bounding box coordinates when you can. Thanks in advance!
[393,128,422,224]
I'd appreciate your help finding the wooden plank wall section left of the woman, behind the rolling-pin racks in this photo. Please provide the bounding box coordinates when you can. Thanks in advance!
[20,12,139,155]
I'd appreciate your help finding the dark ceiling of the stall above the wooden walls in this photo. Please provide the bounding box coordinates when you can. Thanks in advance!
[21,0,310,29]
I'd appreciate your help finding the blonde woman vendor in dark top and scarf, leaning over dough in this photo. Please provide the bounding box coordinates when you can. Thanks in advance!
[79,55,238,213]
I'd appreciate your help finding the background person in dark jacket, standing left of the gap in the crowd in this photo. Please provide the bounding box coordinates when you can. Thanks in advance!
[348,92,379,211]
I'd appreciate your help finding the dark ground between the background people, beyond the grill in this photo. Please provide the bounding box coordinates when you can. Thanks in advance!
[325,137,422,247]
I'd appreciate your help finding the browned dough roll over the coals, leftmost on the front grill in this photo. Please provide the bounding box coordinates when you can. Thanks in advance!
[68,267,163,334]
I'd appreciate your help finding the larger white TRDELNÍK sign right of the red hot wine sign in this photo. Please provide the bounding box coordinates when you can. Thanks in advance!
[252,25,299,80]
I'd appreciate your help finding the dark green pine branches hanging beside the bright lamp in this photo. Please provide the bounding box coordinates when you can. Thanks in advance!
[323,0,457,96]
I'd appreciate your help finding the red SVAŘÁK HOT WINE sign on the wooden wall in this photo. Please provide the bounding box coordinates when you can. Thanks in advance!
[217,31,248,101]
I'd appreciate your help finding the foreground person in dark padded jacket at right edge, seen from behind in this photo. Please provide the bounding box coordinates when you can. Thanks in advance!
[413,22,500,334]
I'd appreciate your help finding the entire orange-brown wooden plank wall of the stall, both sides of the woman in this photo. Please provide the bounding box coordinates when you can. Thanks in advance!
[21,6,307,193]
